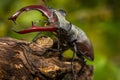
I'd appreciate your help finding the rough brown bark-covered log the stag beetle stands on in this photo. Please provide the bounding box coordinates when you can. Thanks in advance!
[0,37,93,80]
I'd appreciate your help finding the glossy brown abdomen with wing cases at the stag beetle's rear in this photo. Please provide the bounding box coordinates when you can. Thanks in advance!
[76,29,94,61]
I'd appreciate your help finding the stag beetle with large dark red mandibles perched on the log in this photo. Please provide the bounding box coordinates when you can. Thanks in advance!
[9,5,94,79]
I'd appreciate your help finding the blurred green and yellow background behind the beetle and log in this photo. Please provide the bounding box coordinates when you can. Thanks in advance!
[0,0,120,80]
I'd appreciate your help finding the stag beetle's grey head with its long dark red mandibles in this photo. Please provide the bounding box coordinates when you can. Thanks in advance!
[9,5,69,34]
